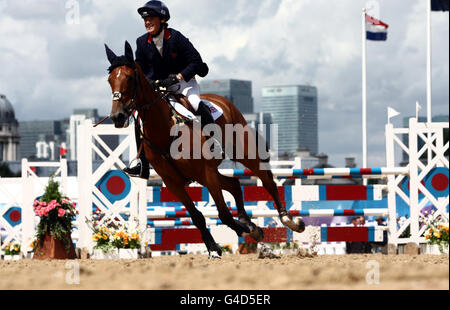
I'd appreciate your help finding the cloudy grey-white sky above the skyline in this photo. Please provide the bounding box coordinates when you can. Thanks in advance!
[0,0,449,167]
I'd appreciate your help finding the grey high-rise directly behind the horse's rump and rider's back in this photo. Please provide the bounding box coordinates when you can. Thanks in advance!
[200,79,253,114]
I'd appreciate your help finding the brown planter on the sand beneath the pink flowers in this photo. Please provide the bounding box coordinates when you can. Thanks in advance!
[33,234,77,260]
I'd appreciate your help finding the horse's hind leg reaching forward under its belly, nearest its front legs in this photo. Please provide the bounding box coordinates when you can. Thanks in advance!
[219,174,264,241]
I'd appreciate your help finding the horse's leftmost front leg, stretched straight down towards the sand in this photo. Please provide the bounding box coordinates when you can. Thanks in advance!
[164,180,222,257]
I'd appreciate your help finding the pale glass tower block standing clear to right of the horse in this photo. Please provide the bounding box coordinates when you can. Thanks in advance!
[262,85,319,155]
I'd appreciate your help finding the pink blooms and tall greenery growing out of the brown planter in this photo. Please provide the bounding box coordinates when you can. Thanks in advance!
[33,176,78,253]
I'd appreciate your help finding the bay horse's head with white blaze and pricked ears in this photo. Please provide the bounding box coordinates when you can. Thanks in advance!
[105,42,138,128]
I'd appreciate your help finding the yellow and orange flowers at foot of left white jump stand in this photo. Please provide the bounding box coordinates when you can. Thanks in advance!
[86,210,141,253]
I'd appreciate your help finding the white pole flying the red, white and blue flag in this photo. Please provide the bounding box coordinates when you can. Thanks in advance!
[361,8,367,185]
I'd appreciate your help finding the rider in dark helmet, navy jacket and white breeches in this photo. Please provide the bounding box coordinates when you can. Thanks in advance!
[123,0,214,179]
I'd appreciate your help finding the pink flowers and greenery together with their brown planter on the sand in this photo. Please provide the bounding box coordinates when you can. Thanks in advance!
[33,176,77,260]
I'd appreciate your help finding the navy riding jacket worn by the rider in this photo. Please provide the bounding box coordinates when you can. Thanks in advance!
[136,28,208,81]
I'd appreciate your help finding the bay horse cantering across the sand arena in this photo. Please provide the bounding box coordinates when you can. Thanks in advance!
[105,42,305,258]
